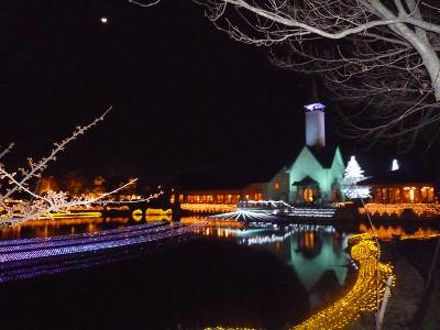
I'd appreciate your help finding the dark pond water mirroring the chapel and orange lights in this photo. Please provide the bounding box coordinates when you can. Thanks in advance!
[0,218,436,329]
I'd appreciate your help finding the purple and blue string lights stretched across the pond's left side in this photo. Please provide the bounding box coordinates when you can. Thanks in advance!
[0,222,196,283]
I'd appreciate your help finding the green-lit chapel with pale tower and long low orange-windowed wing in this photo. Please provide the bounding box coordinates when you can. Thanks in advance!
[175,98,345,209]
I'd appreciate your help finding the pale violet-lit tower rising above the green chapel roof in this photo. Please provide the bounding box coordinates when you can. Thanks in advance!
[304,102,325,148]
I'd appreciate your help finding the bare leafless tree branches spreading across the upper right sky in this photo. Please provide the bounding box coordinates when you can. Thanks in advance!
[188,0,440,146]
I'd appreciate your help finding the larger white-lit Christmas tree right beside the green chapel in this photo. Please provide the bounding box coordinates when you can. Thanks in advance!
[342,156,370,198]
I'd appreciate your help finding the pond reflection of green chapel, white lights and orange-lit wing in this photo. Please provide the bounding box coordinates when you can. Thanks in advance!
[192,219,350,307]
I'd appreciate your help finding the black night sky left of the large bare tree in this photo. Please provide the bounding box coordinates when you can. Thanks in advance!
[0,0,428,182]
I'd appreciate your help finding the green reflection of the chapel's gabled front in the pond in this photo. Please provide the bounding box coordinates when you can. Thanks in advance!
[290,233,349,291]
